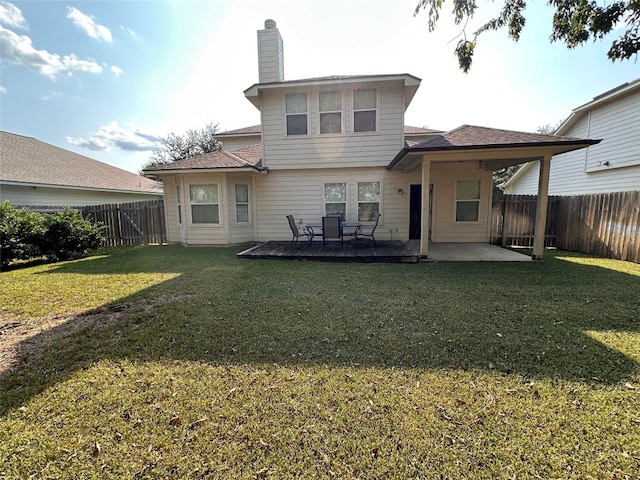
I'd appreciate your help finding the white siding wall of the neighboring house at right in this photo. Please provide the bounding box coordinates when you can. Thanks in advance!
[505,89,640,195]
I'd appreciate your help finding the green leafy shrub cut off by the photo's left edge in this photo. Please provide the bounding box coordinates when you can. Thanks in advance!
[0,201,46,266]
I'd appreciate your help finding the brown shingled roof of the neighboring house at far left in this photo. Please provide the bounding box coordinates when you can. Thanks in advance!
[0,131,162,195]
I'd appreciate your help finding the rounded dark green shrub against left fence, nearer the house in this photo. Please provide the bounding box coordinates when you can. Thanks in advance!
[39,208,104,260]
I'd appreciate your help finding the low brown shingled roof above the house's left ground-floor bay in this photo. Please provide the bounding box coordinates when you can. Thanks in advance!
[145,143,263,174]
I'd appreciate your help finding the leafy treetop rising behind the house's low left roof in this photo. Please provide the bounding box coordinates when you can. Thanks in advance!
[142,123,221,170]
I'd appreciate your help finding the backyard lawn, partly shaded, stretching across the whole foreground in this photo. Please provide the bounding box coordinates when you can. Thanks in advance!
[0,247,640,480]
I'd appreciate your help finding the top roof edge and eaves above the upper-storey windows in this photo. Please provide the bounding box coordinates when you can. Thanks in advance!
[244,73,421,108]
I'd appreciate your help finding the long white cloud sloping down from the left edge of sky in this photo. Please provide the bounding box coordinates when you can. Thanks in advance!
[0,26,102,79]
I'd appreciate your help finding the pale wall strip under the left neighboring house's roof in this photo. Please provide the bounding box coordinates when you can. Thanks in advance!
[0,184,162,207]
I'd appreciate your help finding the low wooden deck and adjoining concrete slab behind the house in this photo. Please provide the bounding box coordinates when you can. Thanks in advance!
[237,240,531,263]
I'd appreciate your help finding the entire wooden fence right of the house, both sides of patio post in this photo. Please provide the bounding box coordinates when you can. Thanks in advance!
[491,191,640,263]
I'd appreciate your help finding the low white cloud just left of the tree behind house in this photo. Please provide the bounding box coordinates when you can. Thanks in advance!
[66,121,161,152]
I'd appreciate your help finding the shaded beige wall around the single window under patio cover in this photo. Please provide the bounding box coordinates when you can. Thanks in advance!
[430,162,493,243]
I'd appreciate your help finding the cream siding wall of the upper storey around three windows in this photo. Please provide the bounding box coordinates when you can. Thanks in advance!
[262,85,404,170]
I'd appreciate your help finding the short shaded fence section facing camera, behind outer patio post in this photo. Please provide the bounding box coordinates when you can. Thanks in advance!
[490,195,560,247]
